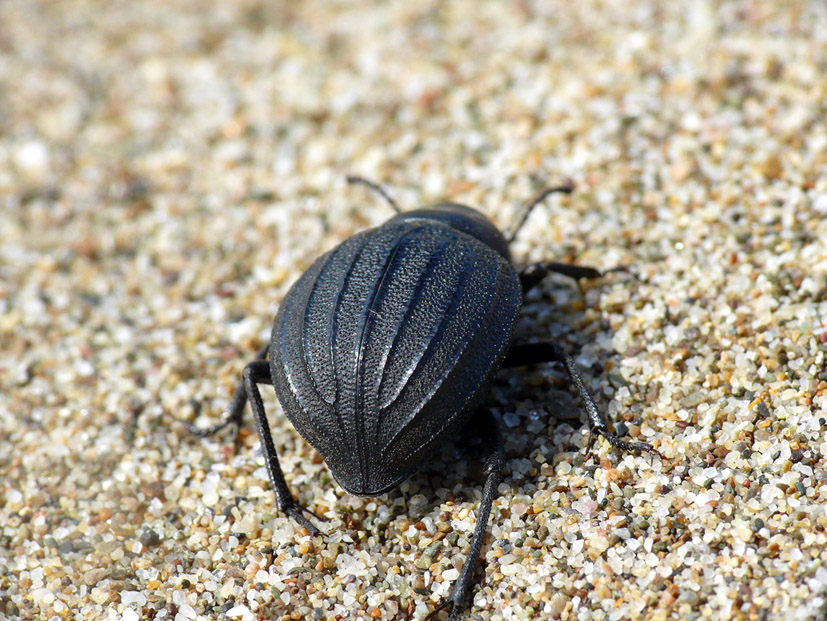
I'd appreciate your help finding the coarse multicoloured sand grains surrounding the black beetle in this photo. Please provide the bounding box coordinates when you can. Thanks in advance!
[0,0,827,621]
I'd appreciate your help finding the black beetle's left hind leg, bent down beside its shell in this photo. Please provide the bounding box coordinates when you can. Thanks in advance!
[241,360,320,535]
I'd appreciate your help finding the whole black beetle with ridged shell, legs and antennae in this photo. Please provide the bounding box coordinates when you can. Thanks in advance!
[194,177,657,618]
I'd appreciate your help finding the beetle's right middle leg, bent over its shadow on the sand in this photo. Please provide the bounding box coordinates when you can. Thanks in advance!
[503,341,660,455]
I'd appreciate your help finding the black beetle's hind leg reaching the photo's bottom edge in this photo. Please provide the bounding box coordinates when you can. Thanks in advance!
[425,408,505,621]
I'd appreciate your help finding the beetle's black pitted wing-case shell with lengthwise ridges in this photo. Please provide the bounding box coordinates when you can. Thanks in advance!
[270,220,522,495]
